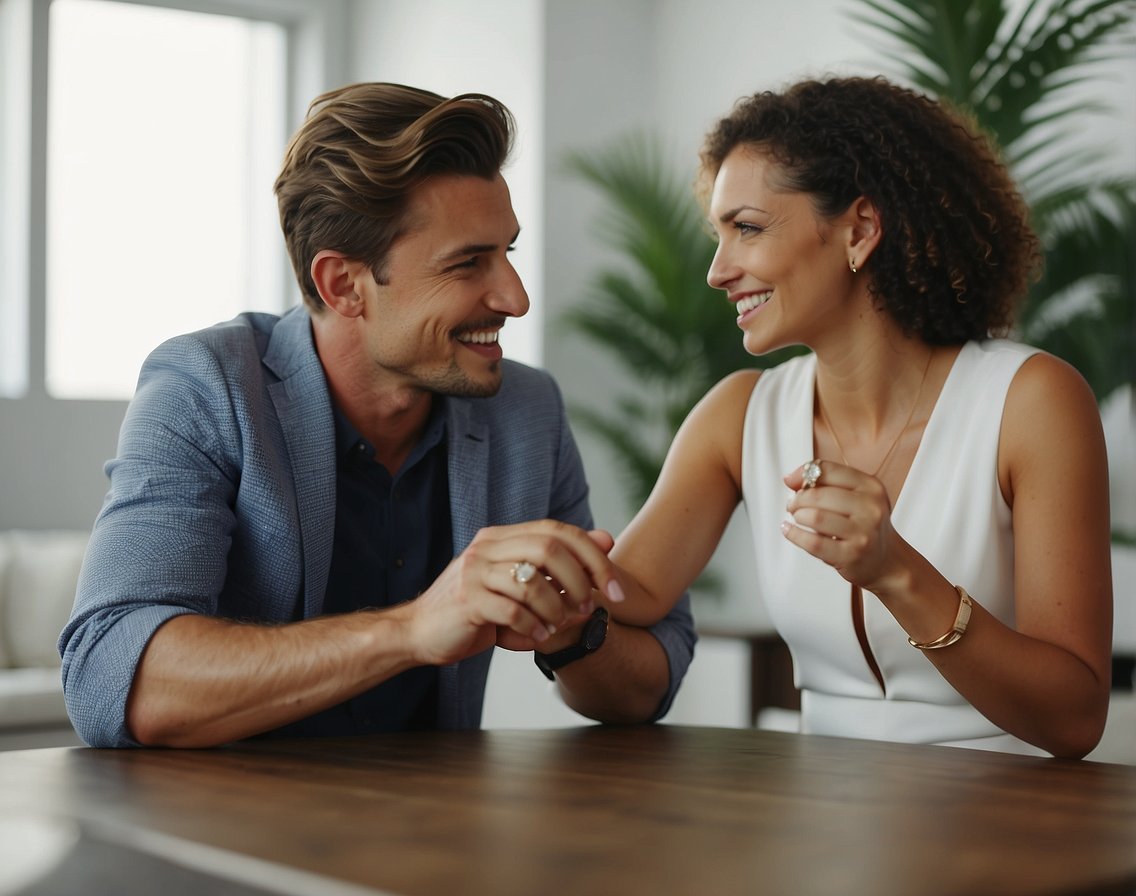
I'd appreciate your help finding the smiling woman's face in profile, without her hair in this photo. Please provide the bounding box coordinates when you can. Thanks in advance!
[707,146,852,354]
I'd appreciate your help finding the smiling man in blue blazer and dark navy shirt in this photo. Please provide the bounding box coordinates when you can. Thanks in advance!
[60,84,694,746]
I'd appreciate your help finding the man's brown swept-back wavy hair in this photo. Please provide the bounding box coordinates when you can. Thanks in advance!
[275,83,516,313]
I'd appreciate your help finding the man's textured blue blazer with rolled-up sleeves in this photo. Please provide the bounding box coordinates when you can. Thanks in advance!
[59,308,695,746]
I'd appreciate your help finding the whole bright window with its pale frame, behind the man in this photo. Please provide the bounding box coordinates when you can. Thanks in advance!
[0,0,342,399]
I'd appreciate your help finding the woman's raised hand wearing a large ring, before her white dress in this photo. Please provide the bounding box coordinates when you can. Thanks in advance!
[782,460,903,592]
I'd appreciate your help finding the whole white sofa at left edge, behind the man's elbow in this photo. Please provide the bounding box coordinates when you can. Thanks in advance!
[0,530,90,750]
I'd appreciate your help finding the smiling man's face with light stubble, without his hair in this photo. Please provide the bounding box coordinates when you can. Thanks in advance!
[357,175,528,396]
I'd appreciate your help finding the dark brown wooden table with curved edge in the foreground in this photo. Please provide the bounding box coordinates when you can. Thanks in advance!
[0,726,1136,896]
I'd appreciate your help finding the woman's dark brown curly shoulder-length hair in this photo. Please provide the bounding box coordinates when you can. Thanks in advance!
[699,77,1041,345]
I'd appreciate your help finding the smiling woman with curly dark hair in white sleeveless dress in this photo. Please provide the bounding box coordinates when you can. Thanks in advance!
[611,78,1112,757]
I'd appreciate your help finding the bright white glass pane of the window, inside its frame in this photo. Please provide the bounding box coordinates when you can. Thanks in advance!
[45,0,286,399]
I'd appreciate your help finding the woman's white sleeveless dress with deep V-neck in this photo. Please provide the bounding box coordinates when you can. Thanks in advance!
[742,340,1049,756]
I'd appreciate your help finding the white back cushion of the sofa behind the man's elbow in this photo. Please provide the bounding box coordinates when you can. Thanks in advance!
[0,530,90,668]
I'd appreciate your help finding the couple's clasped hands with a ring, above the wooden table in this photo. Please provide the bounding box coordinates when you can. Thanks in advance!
[410,520,623,665]
